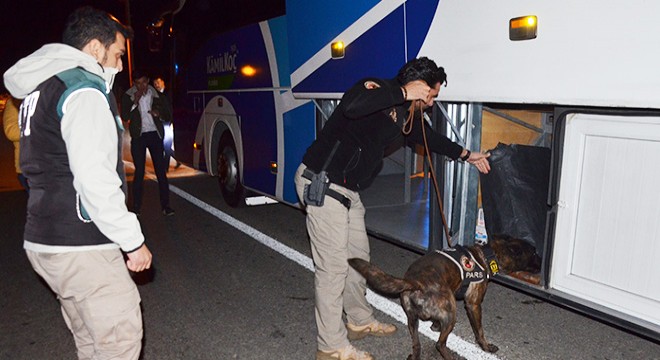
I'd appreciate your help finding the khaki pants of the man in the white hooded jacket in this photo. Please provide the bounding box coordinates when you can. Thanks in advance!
[26,249,142,360]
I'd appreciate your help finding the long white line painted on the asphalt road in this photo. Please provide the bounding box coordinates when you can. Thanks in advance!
[170,184,499,360]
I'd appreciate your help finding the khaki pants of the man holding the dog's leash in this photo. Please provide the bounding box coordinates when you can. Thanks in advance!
[294,164,375,352]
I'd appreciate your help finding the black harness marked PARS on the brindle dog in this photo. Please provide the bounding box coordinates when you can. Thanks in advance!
[436,245,499,299]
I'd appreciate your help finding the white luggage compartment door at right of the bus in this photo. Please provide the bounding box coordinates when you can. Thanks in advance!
[549,113,660,332]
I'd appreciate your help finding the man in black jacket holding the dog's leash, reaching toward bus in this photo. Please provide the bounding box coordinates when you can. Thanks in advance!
[295,57,490,360]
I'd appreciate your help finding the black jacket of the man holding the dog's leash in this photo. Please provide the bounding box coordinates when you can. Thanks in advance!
[303,78,463,191]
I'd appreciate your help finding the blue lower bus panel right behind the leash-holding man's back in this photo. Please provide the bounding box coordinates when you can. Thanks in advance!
[283,102,316,204]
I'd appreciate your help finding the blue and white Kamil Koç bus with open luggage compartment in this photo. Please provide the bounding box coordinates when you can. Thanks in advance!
[155,0,660,341]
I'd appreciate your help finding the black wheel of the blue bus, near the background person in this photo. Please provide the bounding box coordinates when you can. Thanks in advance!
[217,133,244,207]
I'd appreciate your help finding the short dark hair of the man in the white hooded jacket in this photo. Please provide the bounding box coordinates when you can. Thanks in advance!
[62,6,133,50]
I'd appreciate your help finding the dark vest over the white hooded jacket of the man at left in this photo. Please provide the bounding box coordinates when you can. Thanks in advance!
[19,68,125,246]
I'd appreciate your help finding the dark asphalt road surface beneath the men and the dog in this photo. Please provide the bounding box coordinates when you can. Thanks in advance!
[0,134,660,360]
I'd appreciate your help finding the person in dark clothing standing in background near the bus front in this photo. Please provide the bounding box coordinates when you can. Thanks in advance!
[121,71,174,216]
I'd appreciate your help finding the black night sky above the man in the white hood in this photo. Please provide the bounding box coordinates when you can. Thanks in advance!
[0,0,285,93]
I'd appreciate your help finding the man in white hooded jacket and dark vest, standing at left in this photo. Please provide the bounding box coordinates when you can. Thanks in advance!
[4,7,152,360]
